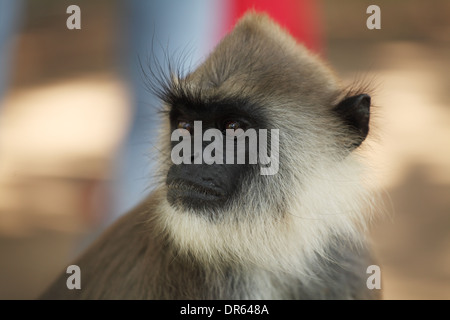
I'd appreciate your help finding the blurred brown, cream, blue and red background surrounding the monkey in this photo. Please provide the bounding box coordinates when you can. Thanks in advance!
[0,0,450,299]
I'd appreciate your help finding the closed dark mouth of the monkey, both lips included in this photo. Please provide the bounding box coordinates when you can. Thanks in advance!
[167,179,226,207]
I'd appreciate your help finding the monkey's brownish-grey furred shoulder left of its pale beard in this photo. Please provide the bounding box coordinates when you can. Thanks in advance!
[39,195,162,300]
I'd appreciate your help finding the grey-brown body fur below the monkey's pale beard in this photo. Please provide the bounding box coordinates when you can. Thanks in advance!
[40,190,378,300]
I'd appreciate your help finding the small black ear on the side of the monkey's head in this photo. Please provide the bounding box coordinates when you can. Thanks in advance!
[334,94,370,150]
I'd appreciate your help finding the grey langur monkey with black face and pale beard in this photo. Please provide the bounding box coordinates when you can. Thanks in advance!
[41,12,380,299]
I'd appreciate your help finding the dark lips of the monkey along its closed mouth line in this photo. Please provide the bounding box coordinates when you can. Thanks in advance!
[167,179,225,201]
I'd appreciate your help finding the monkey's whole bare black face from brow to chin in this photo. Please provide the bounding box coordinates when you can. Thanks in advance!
[166,98,265,218]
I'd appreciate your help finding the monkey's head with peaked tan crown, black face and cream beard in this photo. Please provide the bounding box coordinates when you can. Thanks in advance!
[149,13,371,270]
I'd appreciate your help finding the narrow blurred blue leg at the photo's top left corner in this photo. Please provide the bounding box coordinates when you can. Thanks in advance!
[0,0,23,99]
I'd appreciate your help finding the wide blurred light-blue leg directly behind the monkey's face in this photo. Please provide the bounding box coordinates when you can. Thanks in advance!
[110,0,224,224]
